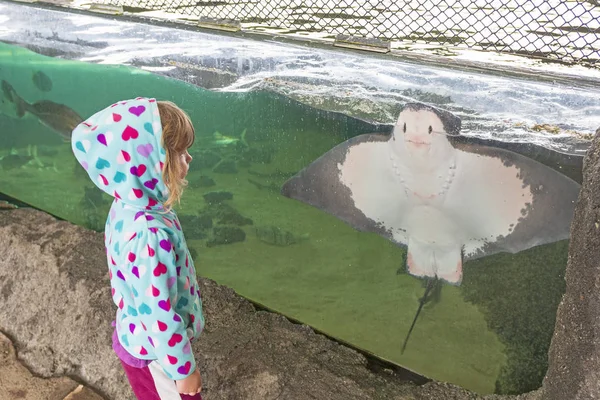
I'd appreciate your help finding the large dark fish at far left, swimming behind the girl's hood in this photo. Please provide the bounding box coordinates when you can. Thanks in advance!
[1,80,83,142]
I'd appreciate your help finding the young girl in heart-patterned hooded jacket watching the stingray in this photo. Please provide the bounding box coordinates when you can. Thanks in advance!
[72,97,204,400]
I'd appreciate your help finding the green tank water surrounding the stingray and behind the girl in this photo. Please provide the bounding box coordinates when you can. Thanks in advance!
[0,44,568,393]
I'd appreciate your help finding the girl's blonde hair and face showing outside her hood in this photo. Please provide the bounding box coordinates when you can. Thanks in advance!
[156,101,195,211]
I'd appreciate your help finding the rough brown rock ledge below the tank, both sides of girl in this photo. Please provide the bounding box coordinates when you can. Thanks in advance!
[0,208,536,400]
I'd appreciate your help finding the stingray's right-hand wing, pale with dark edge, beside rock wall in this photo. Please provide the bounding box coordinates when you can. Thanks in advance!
[447,145,580,259]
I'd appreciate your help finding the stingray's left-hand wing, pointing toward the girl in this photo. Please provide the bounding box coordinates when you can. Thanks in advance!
[281,134,406,244]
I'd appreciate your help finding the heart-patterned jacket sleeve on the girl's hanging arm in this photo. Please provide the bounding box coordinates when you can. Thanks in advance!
[127,228,196,380]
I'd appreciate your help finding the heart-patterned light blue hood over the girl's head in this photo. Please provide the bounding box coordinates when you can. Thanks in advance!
[71,97,168,209]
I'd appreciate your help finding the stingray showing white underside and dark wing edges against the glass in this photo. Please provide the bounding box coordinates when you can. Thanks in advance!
[281,103,580,350]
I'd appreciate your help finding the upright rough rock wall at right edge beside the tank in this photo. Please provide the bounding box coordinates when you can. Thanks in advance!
[541,128,600,400]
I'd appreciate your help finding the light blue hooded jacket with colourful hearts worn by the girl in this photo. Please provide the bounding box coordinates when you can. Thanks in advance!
[71,98,204,380]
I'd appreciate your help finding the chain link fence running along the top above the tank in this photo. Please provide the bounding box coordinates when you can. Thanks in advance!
[101,0,600,67]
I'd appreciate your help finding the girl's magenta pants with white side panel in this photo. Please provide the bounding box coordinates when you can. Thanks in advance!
[121,361,202,400]
